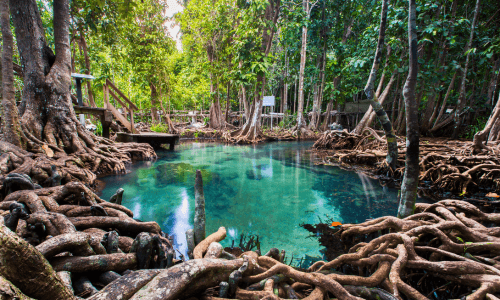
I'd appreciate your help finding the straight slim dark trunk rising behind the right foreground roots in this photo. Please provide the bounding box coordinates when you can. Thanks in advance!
[398,0,419,218]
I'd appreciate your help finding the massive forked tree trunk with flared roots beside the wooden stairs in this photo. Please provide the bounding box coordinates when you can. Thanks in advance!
[10,0,154,179]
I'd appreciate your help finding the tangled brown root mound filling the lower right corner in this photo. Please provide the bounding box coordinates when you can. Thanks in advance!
[304,200,500,299]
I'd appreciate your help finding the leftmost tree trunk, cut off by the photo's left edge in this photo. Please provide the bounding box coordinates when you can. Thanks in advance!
[0,0,26,149]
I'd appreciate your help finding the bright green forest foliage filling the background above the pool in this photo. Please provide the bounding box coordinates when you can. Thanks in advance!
[33,0,500,134]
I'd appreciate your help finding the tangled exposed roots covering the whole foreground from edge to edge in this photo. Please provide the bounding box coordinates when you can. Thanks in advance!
[0,173,500,300]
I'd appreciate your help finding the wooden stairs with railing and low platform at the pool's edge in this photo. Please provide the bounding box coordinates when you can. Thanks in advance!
[72,74,179,150]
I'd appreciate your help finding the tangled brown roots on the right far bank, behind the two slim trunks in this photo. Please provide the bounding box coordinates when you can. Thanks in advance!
[314,128,500,196]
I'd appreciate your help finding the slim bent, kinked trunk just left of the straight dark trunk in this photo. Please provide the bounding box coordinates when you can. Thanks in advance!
[364,0,398,170]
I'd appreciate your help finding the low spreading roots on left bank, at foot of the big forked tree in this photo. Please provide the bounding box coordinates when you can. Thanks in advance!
[0,133,156,190]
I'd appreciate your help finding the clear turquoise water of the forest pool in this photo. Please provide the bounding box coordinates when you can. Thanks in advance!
[101,142,416,257]
